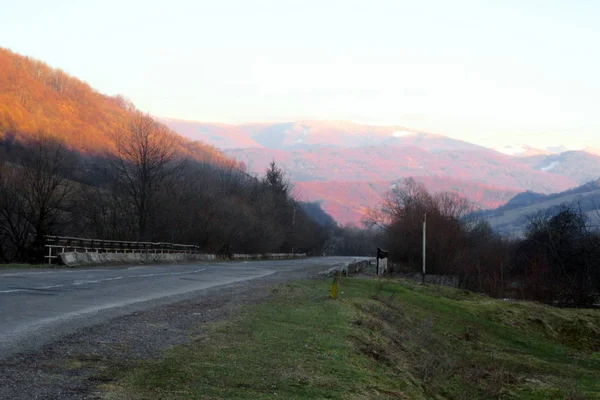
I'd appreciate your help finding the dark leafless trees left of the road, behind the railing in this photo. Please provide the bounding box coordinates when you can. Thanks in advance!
[0,110,330,262]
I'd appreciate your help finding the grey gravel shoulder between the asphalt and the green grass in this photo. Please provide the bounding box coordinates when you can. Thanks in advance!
[0,267,323,400]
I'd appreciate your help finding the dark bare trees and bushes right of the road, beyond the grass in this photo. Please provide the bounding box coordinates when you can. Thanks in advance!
[368,178,600,306]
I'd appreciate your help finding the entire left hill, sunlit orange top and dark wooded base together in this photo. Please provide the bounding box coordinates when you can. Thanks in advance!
[0,49,329,263]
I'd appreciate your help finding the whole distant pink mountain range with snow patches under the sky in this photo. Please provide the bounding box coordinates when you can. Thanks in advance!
[164,119,600,225]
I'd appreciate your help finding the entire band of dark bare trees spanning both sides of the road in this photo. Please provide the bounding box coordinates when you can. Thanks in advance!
[0,103,600,305]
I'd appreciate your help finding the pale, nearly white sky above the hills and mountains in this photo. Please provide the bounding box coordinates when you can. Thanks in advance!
[0,0,600,148]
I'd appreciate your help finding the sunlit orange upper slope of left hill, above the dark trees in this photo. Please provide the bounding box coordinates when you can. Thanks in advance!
[0,48,232,164]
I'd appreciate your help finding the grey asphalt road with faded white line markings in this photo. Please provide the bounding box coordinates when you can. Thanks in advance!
[0,257,350,358]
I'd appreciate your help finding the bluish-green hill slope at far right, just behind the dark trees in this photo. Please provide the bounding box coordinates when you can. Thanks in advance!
[478,179,600,236]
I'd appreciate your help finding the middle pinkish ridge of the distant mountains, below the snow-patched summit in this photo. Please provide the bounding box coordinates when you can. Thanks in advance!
[227,146,577,193]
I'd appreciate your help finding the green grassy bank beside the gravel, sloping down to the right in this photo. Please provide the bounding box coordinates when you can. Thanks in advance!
[104,278,600,399]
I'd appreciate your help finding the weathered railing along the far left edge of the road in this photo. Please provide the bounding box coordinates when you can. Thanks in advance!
[44,236,200,264]
